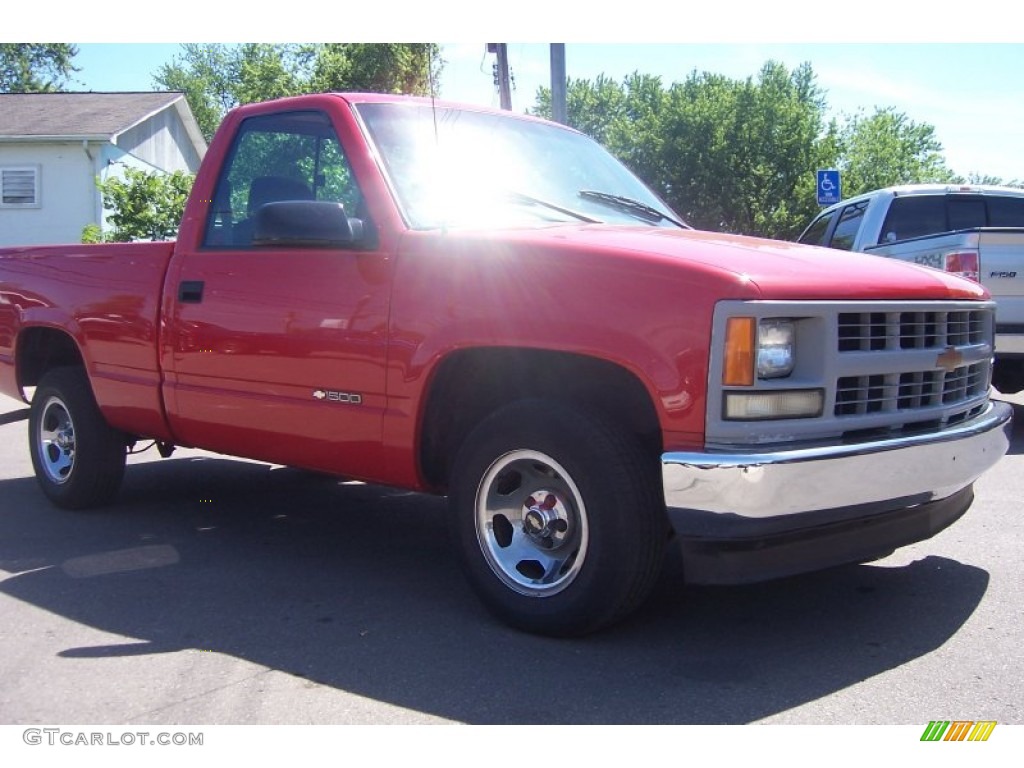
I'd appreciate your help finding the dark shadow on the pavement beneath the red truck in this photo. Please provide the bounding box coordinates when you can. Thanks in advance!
[0,448,988,724]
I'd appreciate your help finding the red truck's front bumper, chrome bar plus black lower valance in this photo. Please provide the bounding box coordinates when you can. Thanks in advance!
[663,402,1013,584]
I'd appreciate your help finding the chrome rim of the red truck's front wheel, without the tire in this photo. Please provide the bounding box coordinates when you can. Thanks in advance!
[476,451,589,597]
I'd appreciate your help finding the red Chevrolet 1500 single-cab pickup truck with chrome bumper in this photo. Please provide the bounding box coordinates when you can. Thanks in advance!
[0,94,1011,635]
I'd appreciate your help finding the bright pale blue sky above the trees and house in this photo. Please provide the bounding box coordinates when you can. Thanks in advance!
[70,42,1024,180]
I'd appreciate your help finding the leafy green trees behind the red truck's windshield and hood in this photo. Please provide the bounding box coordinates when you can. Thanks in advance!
[534,61,1007,239]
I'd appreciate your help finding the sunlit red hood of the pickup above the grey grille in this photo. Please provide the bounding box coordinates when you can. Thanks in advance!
[466,224,988,300]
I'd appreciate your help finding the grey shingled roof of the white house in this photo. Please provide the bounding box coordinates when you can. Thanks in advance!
[0,91,184,137]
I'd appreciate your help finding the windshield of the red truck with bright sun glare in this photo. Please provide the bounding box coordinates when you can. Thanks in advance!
[356,103,679,229]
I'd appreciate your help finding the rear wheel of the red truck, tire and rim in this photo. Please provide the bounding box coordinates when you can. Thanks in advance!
[29,368,127,509]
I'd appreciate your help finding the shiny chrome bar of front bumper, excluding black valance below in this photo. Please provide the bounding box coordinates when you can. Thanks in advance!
[662,401,1013,519]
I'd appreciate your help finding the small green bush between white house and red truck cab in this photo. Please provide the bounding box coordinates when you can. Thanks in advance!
[82,167,195,243]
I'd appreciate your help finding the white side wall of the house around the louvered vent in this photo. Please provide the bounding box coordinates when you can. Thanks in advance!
[0,141,99,246]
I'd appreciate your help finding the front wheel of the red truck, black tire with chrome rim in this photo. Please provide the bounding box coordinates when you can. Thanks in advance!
[450,400,668,637]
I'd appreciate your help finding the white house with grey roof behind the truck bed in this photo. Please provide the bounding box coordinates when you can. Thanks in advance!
[0,92,206,246]
